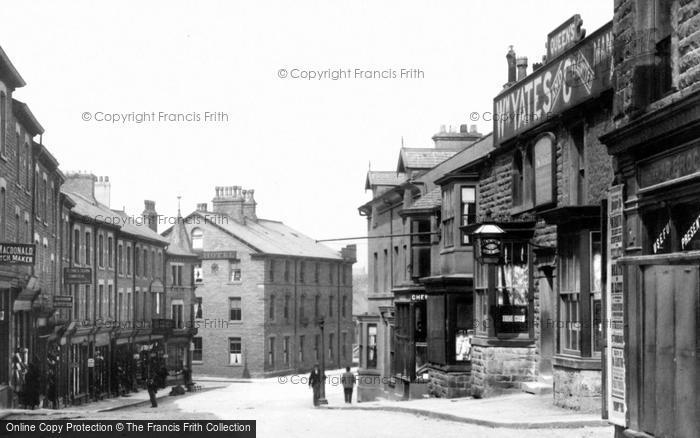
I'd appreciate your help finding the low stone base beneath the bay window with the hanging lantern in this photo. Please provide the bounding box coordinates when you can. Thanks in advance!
[471,345,537,398]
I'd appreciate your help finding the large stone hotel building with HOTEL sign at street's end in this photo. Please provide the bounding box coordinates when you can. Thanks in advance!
[165,186,355,377]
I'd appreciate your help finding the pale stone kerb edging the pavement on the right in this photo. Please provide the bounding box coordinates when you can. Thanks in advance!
[320,406,610,429]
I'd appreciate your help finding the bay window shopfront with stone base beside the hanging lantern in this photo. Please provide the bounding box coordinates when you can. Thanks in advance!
[464,221,537,397]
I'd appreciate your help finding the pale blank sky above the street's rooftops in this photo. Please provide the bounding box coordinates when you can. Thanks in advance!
[0,0,613,267]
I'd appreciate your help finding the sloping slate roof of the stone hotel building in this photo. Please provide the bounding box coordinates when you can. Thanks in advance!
[174,211,342,260]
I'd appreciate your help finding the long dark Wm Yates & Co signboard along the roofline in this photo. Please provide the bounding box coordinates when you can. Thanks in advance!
[493,22,613,144]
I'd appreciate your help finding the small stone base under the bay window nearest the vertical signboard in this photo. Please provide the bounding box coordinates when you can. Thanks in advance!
[553,367,602,412]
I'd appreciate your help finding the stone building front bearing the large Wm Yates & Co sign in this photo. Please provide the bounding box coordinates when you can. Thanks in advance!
[471,19,612,410]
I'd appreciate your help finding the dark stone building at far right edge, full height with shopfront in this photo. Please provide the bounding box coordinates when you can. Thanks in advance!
[601,0,700,438]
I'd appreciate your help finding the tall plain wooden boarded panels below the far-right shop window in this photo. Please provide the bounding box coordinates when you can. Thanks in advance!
[630,265,700,438]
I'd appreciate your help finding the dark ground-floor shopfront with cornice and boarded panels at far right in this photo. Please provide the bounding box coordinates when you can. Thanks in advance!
[601,92,700,438]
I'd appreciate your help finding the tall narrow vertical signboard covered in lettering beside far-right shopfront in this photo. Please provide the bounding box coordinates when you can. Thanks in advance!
[605,185,627,426]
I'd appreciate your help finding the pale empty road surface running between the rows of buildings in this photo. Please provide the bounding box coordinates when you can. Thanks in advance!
[8,372,612,438]
